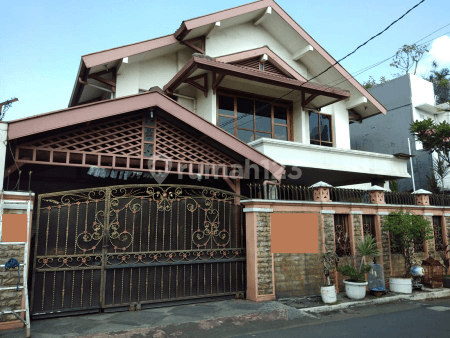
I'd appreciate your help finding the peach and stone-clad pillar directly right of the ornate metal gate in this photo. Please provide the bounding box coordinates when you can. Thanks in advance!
[244,208,275,302]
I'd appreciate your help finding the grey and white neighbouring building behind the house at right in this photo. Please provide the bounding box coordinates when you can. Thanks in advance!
[350,74,450,191]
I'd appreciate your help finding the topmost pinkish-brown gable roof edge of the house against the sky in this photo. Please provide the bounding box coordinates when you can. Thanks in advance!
[69,0,386,115]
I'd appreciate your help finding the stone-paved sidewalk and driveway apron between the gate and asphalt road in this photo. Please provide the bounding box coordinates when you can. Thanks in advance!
[5,289,450,338]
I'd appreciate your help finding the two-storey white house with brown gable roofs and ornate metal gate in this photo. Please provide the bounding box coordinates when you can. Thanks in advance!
[1,0,418,324]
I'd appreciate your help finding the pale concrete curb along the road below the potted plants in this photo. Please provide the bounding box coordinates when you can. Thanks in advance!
[299,289,450,315]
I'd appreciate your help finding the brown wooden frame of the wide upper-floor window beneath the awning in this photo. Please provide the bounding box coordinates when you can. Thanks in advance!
[216,88,294,141]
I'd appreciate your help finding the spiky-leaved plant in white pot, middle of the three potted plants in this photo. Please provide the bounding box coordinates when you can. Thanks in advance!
[337,236,378,299]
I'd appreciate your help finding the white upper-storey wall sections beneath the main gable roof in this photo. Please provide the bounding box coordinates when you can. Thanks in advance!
[112,23,350,149]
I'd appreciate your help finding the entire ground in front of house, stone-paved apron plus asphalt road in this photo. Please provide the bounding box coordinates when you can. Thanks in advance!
[0,298,450,338]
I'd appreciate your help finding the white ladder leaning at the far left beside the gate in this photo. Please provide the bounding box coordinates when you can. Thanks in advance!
[0,191,31,338]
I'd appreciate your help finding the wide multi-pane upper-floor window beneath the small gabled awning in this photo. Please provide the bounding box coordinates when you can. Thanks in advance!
[217,94,290,143]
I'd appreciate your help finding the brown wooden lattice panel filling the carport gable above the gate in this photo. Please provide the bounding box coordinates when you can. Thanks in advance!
[15,109,242,178]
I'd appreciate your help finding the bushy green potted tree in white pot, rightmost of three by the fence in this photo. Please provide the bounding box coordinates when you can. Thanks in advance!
[383,210,433,293]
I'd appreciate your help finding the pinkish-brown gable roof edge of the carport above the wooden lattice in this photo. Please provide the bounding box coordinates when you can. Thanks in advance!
[8,88,285,180]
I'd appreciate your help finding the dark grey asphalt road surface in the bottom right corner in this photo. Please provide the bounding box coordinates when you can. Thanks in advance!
[234,299,450,338]
